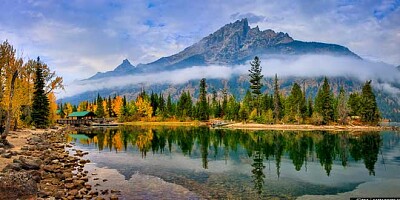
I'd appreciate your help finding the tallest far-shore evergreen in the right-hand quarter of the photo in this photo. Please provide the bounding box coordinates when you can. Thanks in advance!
[315,77,334,124]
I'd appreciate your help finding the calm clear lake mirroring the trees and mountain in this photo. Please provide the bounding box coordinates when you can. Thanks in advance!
[68,126,400,199]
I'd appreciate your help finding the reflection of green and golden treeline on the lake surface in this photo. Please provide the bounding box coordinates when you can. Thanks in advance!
[69,126,382,194]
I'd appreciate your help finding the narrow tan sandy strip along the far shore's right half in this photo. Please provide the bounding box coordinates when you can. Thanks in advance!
[223,123,391,132]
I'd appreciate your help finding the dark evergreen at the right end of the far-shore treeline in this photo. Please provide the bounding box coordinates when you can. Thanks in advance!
[360,81,380,124]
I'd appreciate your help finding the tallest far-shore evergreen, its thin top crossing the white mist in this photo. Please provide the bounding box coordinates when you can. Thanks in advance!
[249,56,264,115]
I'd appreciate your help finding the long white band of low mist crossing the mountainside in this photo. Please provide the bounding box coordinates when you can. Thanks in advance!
[59,55,400,97]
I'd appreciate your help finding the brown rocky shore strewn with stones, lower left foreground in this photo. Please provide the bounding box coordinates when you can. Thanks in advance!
[0,129,118,199]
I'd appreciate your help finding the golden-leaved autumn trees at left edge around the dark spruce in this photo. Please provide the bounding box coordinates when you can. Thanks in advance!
[0,41,63,138]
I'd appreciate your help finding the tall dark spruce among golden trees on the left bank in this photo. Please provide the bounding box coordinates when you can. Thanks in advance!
[31,57,50,128]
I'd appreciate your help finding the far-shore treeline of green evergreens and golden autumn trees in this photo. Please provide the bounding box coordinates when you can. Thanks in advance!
[63,57,380,125]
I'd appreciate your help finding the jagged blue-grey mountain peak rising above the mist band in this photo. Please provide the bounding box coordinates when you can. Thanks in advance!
[89,19,360,79]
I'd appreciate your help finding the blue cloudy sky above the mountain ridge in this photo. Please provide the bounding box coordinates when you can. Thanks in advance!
[0,0,400,84]
